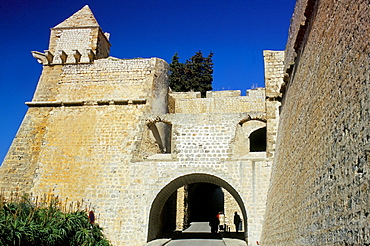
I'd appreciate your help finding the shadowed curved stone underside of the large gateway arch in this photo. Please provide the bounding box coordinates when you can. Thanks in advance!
[147,173,248,242]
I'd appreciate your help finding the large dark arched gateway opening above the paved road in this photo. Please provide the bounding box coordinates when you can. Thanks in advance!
[147,173,248,242]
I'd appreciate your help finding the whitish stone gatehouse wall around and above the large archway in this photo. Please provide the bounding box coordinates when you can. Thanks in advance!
[145,113,271,242]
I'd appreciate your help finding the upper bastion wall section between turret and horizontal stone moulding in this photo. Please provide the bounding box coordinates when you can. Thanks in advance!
[33,58,167,103]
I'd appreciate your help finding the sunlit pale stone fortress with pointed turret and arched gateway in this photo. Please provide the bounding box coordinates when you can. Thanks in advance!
[0,6,284,245]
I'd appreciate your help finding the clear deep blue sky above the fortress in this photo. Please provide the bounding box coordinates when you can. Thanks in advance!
[0,0,295,163]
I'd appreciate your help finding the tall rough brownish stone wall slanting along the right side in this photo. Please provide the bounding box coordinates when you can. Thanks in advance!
[262,0,370,245]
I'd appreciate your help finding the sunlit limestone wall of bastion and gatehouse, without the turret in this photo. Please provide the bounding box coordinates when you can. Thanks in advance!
[0,50,270,245]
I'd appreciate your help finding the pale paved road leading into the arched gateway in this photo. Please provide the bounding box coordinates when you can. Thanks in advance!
[166,222,225,246]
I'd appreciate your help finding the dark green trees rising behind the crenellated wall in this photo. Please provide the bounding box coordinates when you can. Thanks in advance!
[169,51,213,97]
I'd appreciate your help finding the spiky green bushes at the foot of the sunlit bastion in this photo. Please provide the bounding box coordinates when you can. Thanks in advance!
[0,196,110,246]
